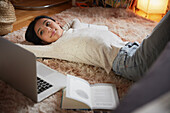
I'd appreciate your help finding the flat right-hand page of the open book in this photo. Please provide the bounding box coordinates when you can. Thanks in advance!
[91,83,118,109]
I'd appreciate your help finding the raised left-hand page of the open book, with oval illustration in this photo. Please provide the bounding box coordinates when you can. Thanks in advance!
[66,75,91,107]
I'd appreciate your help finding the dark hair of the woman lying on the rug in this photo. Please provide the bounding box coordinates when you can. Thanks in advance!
[25,15,55,45]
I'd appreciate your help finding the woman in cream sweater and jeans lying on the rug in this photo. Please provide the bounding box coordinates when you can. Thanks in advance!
[19,11,170,81]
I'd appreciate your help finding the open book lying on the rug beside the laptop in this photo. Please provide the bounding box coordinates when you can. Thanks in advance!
[61,75,119,110]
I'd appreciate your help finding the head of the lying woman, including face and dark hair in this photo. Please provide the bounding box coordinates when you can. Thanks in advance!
[25,16,63,45]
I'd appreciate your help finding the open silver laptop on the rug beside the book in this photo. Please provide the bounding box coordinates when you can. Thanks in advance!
[0,37,66,102]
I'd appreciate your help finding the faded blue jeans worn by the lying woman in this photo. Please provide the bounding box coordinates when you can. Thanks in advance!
[113,11,170,81]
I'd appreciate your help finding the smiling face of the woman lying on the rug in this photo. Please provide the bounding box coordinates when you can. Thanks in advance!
[34,18,63,43]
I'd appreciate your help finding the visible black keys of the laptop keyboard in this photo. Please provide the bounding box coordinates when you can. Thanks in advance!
[37,77,52,94]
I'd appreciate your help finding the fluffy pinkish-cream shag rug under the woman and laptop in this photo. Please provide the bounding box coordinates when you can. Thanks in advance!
[0,7,157,113]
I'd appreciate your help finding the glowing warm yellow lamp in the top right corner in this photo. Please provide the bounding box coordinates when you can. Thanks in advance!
[137,0,168,14]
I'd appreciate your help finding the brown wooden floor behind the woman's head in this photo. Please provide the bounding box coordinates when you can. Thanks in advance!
[12,0,72,32]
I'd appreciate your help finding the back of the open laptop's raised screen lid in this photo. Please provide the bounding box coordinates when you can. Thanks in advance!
[0,37,37,100]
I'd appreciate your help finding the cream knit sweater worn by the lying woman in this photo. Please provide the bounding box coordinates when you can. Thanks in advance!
[18,19,126,73]
